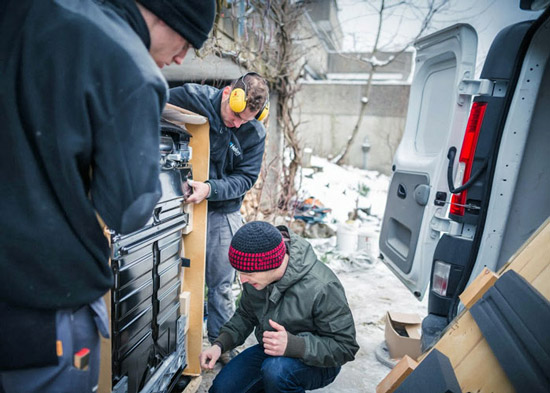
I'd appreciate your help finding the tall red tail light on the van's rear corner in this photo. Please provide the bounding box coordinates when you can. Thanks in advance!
[450,102,487,216]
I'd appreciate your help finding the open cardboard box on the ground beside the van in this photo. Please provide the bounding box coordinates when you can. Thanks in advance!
[385,311,422,359]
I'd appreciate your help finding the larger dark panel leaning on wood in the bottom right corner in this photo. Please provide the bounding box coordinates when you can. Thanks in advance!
[470,270,550,393]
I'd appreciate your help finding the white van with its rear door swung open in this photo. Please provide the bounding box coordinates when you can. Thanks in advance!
[380,0,550,349]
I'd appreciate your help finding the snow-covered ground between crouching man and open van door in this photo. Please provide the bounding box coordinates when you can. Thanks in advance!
[199,157,427,393]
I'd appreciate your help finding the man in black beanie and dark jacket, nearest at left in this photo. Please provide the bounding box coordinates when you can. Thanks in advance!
[0,0,215,393]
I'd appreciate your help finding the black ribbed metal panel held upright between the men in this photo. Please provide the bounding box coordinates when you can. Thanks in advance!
[111,137,192,393]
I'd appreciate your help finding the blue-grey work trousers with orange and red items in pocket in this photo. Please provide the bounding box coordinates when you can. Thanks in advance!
[0,298,109,393]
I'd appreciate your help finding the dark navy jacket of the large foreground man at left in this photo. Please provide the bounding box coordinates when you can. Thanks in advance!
[0,0,167,309]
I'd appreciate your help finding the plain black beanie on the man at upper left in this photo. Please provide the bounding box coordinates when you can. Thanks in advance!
[138,0,216,49]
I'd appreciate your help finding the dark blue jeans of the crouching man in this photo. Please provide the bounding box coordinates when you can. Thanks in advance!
[209,344,340,393]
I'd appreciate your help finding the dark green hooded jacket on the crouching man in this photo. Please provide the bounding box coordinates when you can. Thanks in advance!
[216,226,359,367]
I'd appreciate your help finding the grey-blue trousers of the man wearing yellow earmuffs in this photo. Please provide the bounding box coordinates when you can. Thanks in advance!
[205,211,243,343]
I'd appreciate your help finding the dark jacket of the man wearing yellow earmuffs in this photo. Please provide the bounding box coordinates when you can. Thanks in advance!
[169,83,265,213]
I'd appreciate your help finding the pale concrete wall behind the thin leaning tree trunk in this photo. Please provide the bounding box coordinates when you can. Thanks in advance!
[296,81,410,174]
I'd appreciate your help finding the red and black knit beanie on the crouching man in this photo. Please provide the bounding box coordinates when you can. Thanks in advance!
[229,221,286,273]
